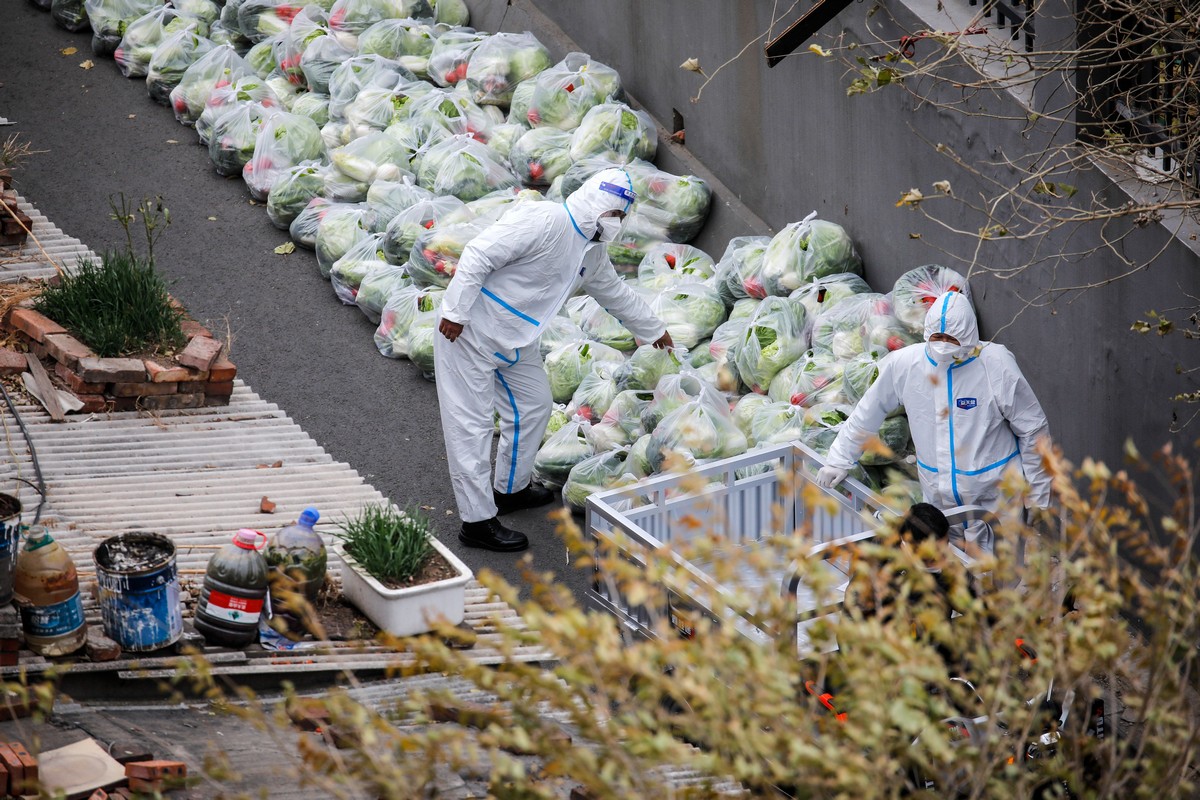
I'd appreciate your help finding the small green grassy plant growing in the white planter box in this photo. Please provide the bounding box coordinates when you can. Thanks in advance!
[335,503,433,584]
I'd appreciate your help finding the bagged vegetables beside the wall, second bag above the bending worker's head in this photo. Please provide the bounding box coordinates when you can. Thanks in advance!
[526,53,624,131]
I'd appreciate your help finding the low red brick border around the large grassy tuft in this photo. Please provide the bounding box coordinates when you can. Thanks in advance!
[4,307,238,413]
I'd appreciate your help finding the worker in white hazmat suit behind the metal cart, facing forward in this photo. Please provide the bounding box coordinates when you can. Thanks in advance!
[816,291,1050,549]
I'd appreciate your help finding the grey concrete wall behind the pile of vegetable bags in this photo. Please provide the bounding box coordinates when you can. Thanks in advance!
[470,0,1200,465]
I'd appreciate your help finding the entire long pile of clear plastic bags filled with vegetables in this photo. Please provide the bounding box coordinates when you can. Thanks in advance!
[48,0,970,510]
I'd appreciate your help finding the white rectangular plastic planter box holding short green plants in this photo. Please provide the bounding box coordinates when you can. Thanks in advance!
[331,539,473,636]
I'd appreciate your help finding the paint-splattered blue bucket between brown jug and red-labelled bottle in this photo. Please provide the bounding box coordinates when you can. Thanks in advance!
[92,531,184,651]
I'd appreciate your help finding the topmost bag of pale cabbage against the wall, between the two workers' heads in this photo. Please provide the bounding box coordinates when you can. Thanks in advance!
[762,211,863,296]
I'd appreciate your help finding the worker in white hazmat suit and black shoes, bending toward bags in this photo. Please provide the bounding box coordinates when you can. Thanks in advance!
[433,169,672,552]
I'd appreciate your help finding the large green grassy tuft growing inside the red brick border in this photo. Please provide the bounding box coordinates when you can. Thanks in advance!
[35,252,187,357]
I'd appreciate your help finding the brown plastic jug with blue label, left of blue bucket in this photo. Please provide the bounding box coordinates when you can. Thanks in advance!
[13,525,88,656]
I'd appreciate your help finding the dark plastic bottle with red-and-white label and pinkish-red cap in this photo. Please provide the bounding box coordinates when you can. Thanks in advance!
[193,528,268,648]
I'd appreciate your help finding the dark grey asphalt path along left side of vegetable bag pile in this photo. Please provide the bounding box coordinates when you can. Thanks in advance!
[0,6,588,599]
